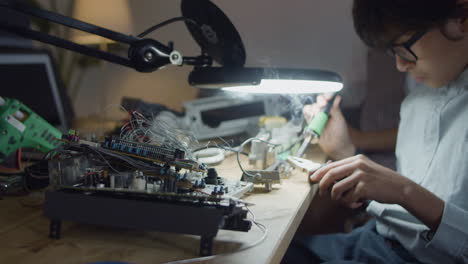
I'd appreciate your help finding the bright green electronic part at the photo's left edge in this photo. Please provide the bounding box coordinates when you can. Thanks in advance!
[0,97,62,162]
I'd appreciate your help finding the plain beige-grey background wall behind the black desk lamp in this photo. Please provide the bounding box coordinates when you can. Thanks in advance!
[41,0,367,117]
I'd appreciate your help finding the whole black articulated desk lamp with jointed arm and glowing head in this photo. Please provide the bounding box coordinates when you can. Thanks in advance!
[0,0,343,94]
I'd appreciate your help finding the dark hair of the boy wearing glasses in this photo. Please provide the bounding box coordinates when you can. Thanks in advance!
[353,0,468,49]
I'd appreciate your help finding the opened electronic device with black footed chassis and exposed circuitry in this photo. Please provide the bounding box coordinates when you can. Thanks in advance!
[44,135,253,255]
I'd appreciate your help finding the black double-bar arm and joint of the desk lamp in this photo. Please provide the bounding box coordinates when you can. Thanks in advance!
[0,0,211,72]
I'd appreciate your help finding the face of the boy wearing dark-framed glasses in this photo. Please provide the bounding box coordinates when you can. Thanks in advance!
[396,22,468,88]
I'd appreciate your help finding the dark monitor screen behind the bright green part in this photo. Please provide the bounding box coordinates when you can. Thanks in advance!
[0,49,73,132]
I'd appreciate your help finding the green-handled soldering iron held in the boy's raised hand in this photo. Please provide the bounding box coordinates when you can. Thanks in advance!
[296,93,338,158]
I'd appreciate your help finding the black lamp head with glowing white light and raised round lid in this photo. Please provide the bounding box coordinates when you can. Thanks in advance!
[181,0,343,94]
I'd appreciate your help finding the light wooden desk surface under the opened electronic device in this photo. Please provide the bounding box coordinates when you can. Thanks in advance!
[0,145,323,264]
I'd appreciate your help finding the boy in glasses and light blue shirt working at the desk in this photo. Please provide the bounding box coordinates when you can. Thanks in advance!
[283,0,468,263]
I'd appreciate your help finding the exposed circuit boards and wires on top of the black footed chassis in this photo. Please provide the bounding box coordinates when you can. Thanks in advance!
[49,132,253,202]
